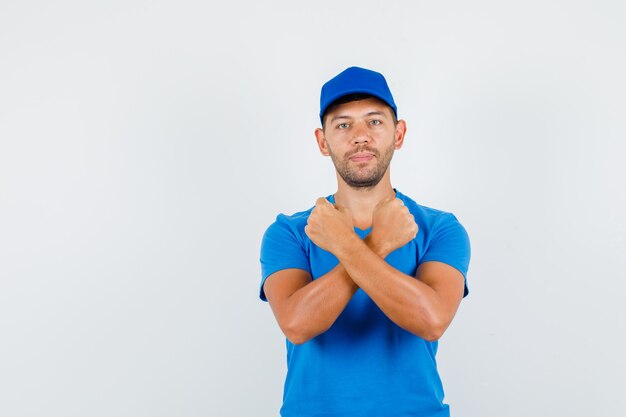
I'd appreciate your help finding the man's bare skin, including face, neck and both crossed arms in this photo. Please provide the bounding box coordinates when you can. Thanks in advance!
[264,98,464,344]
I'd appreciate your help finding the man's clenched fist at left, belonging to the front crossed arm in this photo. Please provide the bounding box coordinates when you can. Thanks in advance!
[304,197,358,254]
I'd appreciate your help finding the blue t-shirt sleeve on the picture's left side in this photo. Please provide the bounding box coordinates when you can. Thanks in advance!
[259,215,311,301]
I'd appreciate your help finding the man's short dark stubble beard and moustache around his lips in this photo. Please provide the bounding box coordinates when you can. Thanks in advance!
[330,144,394,190]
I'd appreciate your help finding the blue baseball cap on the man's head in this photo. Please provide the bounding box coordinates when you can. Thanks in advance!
[320,67,398,122]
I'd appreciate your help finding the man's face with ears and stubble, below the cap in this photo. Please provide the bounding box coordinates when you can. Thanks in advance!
[316,98,404,188]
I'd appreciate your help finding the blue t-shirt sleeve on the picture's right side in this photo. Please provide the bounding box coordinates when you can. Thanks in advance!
[420,213,471,297]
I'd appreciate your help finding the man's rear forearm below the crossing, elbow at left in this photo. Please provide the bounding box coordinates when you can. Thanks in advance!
[280,264,358,344]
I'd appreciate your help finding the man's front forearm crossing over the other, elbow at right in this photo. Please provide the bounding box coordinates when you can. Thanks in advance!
[335,237,451,340]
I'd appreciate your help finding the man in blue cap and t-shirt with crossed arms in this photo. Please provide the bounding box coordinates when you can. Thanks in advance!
[261,67,470,417]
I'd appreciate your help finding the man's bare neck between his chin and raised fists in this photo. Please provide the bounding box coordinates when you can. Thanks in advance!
[335,176,395,229]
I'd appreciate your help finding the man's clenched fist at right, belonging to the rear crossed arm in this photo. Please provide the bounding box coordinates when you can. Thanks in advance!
[367,197,418,257]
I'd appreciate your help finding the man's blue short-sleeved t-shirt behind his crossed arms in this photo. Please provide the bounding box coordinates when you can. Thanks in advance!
[260,190,470,417]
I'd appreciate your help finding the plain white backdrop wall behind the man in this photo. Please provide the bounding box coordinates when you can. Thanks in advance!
[0,0,626,417]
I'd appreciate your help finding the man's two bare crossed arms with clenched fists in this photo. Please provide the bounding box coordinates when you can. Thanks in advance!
[264,199,464,344]
